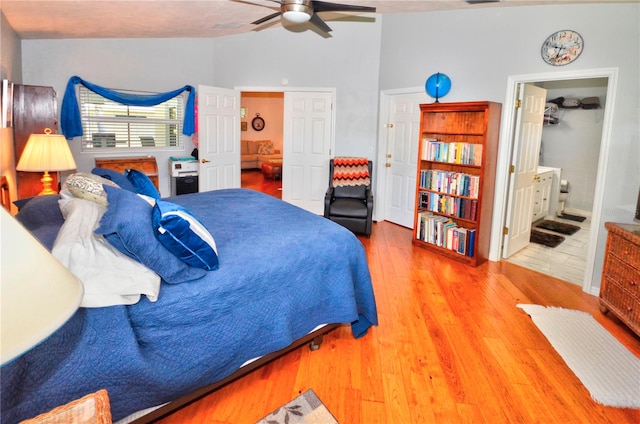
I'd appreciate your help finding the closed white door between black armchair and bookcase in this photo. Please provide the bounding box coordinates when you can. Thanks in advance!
[384,93,427,228]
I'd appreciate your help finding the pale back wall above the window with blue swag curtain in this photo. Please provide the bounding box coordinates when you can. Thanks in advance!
[22,21,380,196]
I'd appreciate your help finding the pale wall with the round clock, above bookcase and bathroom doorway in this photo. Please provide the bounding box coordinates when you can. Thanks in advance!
[380,3,640,294]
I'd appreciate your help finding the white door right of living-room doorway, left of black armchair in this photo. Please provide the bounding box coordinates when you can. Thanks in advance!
[282,92,333,215]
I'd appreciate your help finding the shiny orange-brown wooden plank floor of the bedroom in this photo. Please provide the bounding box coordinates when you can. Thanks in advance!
[156,212,640,424]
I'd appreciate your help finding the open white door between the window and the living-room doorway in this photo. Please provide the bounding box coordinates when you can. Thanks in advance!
[198,85,240,191]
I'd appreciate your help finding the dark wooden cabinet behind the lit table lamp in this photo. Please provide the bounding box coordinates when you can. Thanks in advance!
[13,84,58,199]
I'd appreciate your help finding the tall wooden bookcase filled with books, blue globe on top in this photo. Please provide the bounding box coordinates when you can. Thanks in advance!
[413,102,502,266]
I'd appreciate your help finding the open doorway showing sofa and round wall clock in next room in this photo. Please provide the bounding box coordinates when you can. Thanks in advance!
[240,91,284,199]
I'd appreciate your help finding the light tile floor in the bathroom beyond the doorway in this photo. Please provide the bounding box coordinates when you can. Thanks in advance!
[507,211,591,286]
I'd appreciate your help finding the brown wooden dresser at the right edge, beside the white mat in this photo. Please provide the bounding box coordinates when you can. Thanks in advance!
[600,222,640,336]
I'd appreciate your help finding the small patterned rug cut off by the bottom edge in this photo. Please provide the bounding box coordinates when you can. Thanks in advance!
[256,389,338,424]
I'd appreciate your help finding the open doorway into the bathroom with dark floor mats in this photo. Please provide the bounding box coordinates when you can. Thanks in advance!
[503,78,607,285]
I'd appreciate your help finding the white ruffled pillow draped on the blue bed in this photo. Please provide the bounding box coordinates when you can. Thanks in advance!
[51,198,160,308]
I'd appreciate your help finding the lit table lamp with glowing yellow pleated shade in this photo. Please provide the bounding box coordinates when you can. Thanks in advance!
[16,128,76,196]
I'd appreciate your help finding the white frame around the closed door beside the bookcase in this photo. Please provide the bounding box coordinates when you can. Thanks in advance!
[373,86,425,221]
